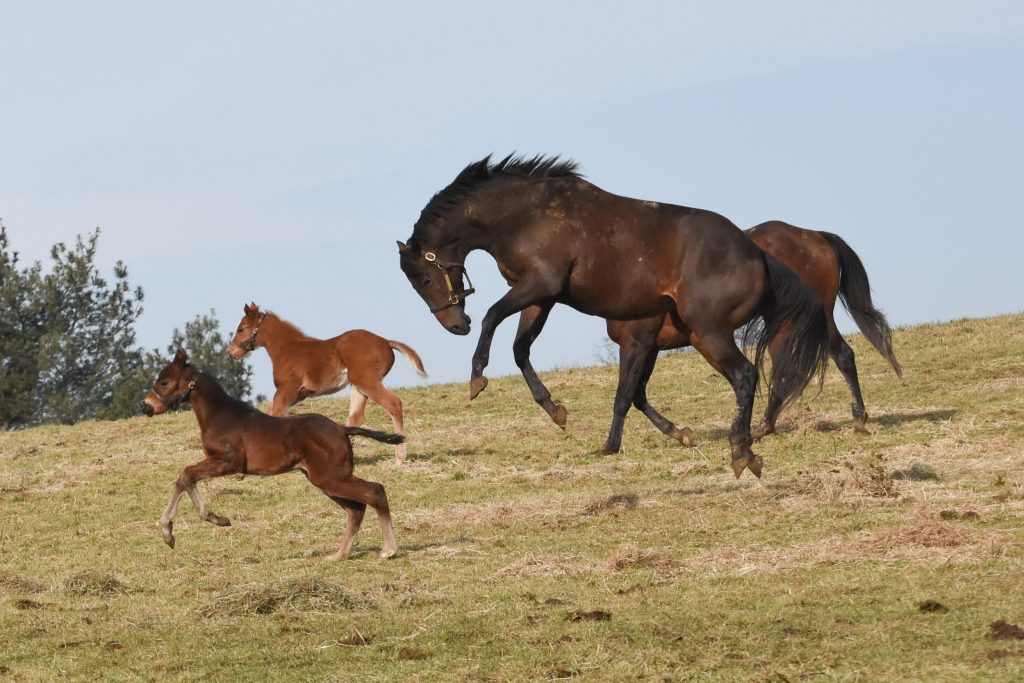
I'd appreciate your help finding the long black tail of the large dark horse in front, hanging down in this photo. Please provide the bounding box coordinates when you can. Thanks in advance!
[743,252,828,405]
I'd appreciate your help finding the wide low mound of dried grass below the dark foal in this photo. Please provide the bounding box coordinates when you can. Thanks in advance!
[199,578,369,616]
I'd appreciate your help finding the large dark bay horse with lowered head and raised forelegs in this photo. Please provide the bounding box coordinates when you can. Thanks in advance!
[398,157,827,476]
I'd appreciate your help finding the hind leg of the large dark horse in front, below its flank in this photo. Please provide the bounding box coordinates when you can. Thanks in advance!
[691,331,763,478]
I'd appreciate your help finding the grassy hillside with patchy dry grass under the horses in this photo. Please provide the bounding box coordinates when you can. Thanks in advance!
[0,315,1024,681]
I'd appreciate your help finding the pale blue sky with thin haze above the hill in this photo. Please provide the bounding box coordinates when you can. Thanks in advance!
[0,0,1024,400]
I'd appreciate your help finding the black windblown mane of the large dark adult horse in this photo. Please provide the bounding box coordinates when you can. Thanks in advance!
[413,154,583,233]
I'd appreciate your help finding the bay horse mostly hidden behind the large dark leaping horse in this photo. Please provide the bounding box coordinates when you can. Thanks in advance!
[520,220,903,445]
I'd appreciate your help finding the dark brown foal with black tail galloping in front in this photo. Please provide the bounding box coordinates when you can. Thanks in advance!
[142,349,403,560]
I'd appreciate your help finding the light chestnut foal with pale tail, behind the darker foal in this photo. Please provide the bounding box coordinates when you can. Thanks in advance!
[227,303,427,463]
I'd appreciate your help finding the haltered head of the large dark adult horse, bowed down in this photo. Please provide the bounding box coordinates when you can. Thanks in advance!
[398,240,474,335]
